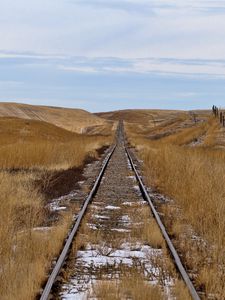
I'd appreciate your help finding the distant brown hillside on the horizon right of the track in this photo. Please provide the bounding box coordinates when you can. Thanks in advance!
[97,109,213,144]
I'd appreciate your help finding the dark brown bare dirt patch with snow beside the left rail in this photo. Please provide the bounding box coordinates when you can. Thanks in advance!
[40,147,110,226]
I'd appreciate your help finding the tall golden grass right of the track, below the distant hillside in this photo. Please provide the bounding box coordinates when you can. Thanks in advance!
[126,112,225,299]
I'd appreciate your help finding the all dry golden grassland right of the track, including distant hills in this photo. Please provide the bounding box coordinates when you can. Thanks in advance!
[106,111,225,299]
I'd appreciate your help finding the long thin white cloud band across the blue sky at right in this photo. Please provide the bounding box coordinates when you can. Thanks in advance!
[57,57,225,78]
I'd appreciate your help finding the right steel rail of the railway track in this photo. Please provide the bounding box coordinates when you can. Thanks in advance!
[125,146,200,300]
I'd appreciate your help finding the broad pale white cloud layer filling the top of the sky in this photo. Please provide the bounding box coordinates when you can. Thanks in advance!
[0,0,225,59]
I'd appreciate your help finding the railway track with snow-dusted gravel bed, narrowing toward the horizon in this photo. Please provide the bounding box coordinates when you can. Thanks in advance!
[40,123,200,300]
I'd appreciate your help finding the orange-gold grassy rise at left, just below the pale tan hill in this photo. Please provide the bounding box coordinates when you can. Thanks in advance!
[0,118,112,169]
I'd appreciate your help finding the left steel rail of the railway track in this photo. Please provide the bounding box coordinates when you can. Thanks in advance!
[40,145,116,300]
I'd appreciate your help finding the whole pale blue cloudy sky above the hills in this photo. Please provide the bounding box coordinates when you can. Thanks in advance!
[0,0,225,112]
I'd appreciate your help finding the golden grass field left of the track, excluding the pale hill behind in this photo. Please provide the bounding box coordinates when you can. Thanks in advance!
[0,109,112,300]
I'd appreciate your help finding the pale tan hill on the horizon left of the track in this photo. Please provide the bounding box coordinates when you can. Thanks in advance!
[0,103,109,133]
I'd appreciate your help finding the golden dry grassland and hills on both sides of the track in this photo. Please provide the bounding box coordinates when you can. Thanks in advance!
[0,104,225,300]
